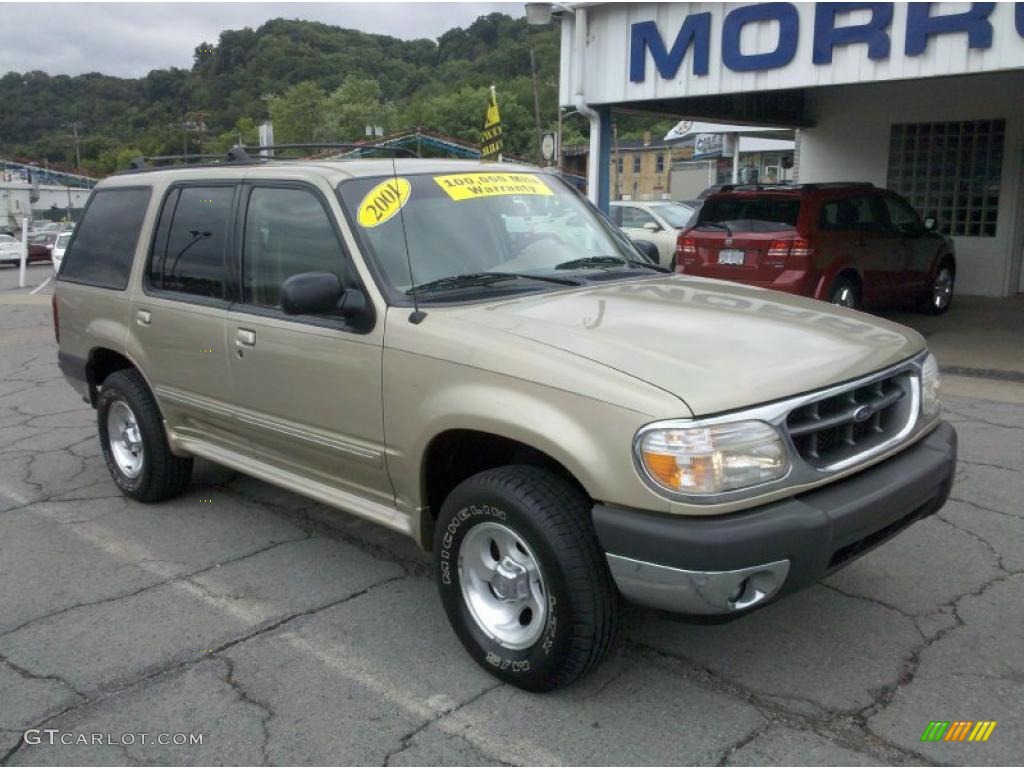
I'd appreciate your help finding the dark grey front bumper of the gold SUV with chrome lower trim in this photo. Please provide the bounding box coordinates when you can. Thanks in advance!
[593,422,956,615]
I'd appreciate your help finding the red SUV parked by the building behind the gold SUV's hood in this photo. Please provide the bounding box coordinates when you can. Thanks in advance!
[676,182,956,314]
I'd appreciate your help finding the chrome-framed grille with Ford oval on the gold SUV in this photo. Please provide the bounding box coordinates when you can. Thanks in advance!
[785,371,913,469]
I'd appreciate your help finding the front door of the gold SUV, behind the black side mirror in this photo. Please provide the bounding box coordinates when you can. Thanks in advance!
[227,182,394,509]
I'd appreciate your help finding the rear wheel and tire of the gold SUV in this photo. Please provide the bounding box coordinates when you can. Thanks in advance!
[96,369,193,503]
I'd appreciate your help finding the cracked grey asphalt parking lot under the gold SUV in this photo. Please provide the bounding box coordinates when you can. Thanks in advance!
[0,264,1024,765]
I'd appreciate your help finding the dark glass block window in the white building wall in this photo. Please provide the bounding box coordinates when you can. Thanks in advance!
[887,120,1006,238]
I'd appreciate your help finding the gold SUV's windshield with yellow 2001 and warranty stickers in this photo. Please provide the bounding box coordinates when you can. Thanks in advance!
[339,171,650,299]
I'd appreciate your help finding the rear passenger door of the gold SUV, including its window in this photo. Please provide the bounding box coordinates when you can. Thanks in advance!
[130,183,238,439]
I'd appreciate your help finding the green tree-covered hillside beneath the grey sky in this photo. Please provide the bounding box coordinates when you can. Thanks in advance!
[0,13,580,174]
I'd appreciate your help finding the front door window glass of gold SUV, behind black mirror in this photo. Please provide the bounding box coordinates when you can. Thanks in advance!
[242,187,348,308]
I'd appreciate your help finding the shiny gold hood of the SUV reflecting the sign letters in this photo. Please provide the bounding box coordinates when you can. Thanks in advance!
[454,275,925,416]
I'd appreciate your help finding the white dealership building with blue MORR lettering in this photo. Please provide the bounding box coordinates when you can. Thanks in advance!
[552,2,1024,296]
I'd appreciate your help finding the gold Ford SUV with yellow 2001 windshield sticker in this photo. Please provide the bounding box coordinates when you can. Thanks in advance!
[53,158,956,690]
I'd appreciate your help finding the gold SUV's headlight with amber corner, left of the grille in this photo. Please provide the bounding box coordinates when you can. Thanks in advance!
[637,421,790,495]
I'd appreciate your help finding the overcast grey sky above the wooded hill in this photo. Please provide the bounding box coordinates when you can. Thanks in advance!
[0,2,524,77]
